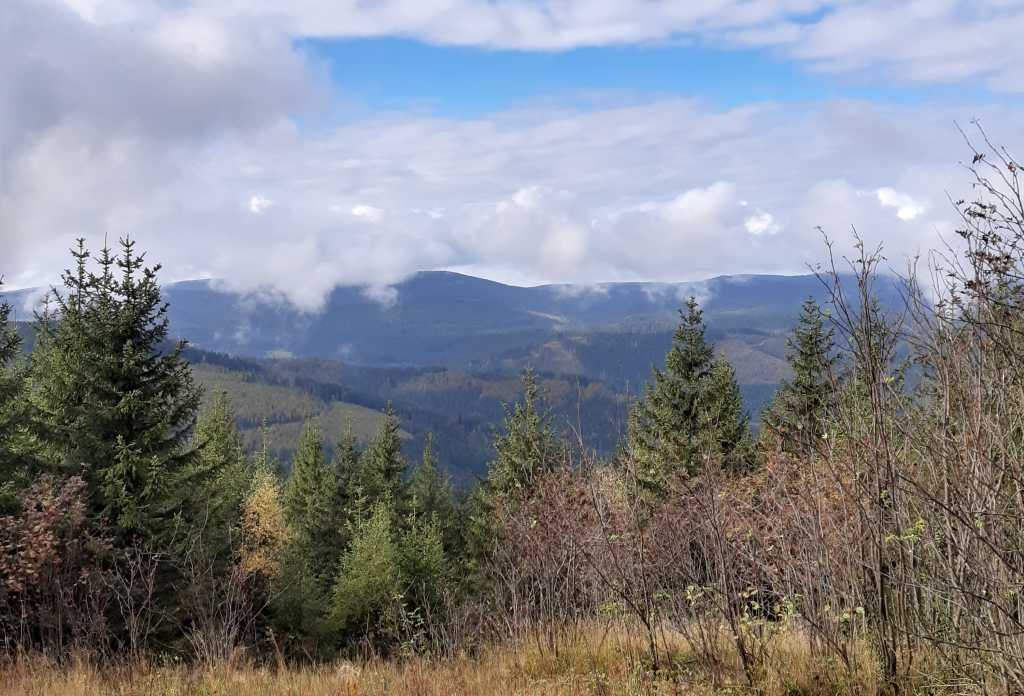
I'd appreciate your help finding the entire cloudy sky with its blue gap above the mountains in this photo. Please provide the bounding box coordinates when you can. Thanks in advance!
[0,0,1024,311]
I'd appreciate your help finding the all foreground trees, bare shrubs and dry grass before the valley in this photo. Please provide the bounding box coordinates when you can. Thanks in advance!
[0,130,1024,694]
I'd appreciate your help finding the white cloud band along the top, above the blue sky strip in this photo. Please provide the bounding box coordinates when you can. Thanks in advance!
[65,0,1024,91]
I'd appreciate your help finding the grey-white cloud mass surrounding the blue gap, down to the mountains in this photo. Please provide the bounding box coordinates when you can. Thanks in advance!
[0,0,1022,310]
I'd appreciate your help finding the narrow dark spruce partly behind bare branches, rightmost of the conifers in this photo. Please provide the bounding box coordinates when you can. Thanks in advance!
[762,298,837,455]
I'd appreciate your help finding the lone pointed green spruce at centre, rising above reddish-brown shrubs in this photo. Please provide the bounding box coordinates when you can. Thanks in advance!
[487,369,564,495]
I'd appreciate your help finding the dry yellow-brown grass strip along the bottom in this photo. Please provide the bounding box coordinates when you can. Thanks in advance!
[0,626,951,696]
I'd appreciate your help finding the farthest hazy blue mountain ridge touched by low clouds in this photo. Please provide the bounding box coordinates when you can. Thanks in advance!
[159,271,843,368]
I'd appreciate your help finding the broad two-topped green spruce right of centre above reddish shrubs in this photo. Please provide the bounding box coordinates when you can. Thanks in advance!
[629,298,750,488]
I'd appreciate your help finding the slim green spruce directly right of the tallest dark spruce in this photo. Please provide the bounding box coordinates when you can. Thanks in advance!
[194,392,251,558]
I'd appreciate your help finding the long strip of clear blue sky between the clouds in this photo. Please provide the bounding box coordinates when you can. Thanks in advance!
[296,38,1008,118]
